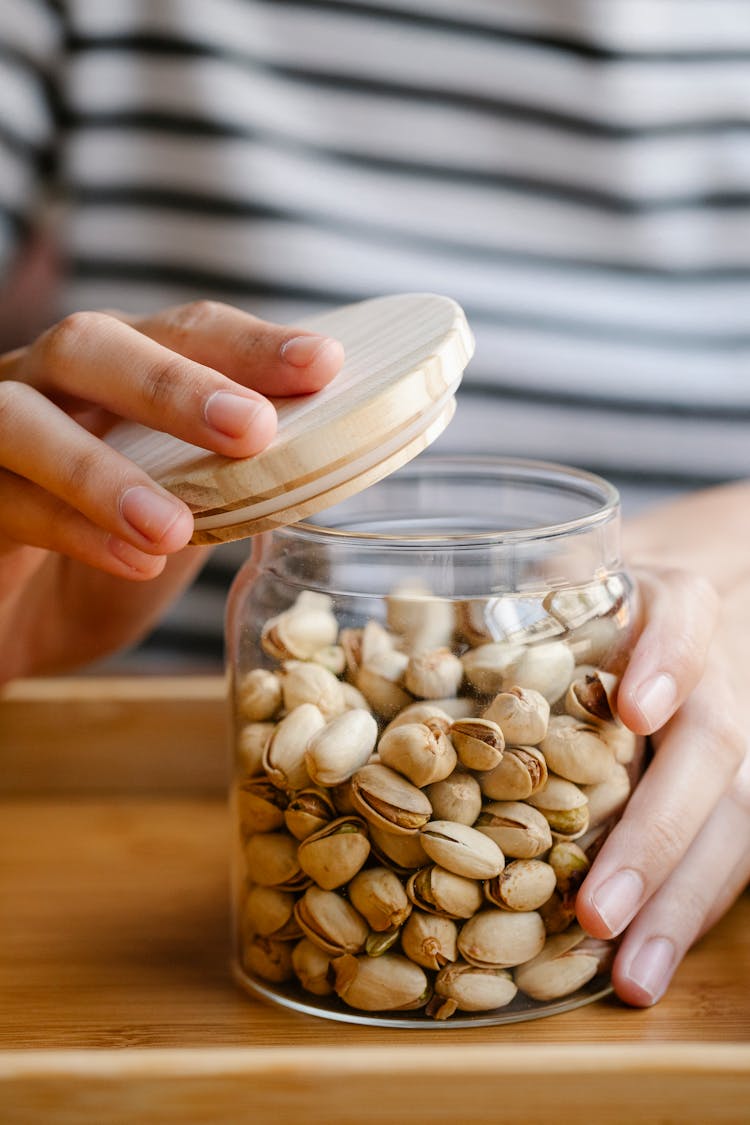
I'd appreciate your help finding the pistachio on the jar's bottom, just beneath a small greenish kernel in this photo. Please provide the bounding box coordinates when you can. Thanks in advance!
[333,953,430,1011]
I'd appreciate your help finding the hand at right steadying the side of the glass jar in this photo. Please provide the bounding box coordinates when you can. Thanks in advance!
[577,517,750,1007]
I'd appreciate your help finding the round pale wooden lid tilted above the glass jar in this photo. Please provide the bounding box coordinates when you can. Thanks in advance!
[108,294,473,543]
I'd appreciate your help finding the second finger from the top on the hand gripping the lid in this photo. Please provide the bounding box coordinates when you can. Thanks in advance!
[16,313,281,457]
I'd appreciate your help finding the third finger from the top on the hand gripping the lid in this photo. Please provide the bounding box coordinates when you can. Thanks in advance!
[0,383,193,555]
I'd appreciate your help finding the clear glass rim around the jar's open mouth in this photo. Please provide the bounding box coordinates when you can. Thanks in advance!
[283,453,620,550]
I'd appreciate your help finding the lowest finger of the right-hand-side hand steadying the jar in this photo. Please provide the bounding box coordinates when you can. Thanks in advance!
[613,759,750,1007]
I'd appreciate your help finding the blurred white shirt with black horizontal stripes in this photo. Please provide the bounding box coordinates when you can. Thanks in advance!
[0,0,750,651]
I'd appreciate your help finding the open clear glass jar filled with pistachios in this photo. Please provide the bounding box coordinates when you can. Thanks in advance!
[227,457,642,1027]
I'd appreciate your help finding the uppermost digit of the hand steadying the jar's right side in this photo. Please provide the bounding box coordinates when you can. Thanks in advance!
[617,569,719,735]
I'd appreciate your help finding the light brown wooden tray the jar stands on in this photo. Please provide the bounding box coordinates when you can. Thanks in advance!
[0,682,750,1125]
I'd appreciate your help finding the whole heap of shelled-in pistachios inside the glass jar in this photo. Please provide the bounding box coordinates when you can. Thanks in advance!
[234,579,638,1019]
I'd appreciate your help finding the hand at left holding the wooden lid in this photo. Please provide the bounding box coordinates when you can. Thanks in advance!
[0,302,343,680]
